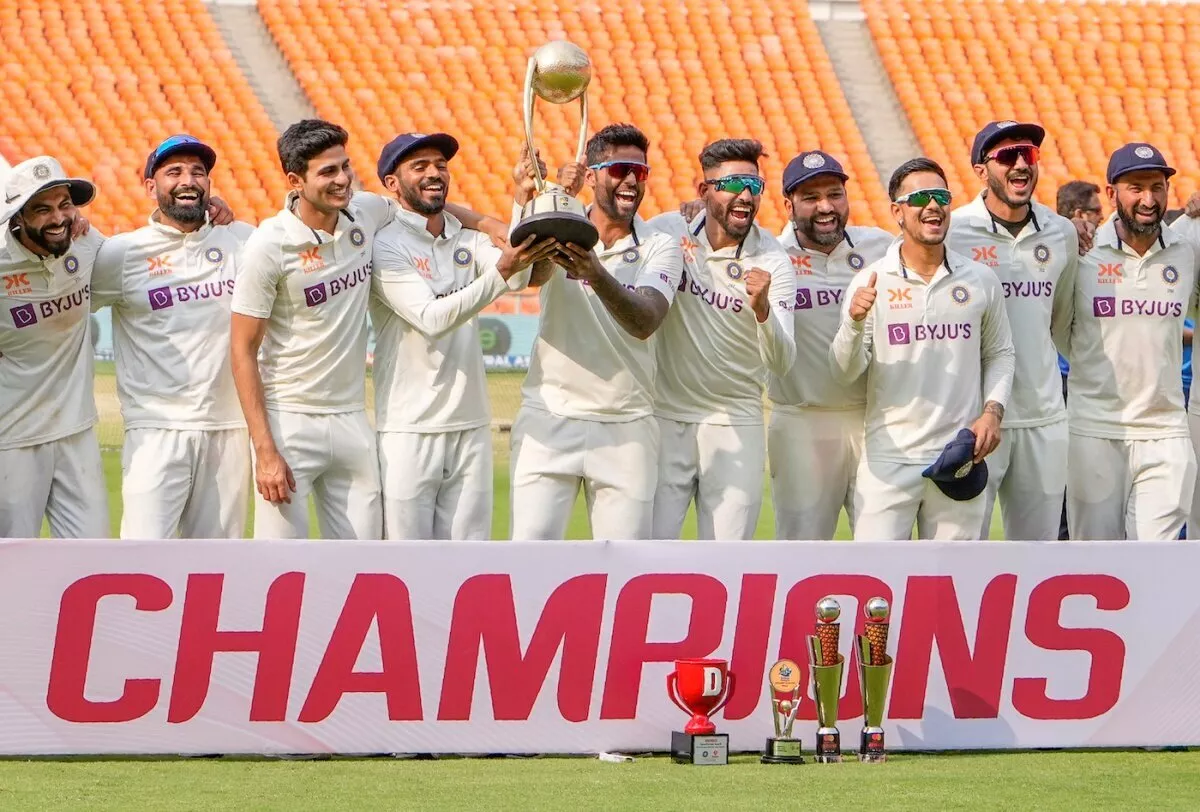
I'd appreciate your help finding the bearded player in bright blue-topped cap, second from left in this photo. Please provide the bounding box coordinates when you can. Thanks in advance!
[92,136,254,539]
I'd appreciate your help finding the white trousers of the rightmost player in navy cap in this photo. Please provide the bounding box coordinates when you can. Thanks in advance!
[1067,434,1196,541]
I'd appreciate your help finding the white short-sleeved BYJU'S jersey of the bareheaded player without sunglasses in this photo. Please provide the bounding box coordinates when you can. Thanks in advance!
[226,192,392,414]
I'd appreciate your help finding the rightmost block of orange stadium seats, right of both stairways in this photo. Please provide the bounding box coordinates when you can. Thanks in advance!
[862,0,1200,212]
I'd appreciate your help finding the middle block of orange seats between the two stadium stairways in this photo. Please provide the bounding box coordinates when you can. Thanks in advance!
[258,0,889,278]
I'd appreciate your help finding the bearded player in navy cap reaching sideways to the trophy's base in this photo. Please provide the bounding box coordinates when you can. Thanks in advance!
[371,133,556,540]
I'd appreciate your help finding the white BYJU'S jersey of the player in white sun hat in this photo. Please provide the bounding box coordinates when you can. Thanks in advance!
[0,223,104,451]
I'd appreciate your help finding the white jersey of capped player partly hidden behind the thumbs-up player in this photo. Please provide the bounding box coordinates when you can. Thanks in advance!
[767,223,895,411]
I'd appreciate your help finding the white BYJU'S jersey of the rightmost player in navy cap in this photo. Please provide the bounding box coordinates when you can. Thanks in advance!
[1055,216,1200,440]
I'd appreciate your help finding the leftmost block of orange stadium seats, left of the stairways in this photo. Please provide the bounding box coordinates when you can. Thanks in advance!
[0,0,284,234]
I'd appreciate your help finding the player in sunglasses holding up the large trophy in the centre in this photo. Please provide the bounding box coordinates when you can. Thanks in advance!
[510,124,682,540]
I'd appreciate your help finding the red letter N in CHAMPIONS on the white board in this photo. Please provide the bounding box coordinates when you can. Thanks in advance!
[888,573,1016,718]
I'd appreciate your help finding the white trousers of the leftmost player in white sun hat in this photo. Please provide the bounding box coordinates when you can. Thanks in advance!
[0,428,112,539]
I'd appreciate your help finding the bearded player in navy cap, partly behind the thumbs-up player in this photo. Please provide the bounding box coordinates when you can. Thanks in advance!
[767,150,894,539]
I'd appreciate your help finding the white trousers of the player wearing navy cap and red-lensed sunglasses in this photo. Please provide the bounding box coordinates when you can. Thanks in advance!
[979,420,1068,541]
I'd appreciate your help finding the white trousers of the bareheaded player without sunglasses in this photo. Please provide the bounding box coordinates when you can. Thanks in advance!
[254,410,383,539]
